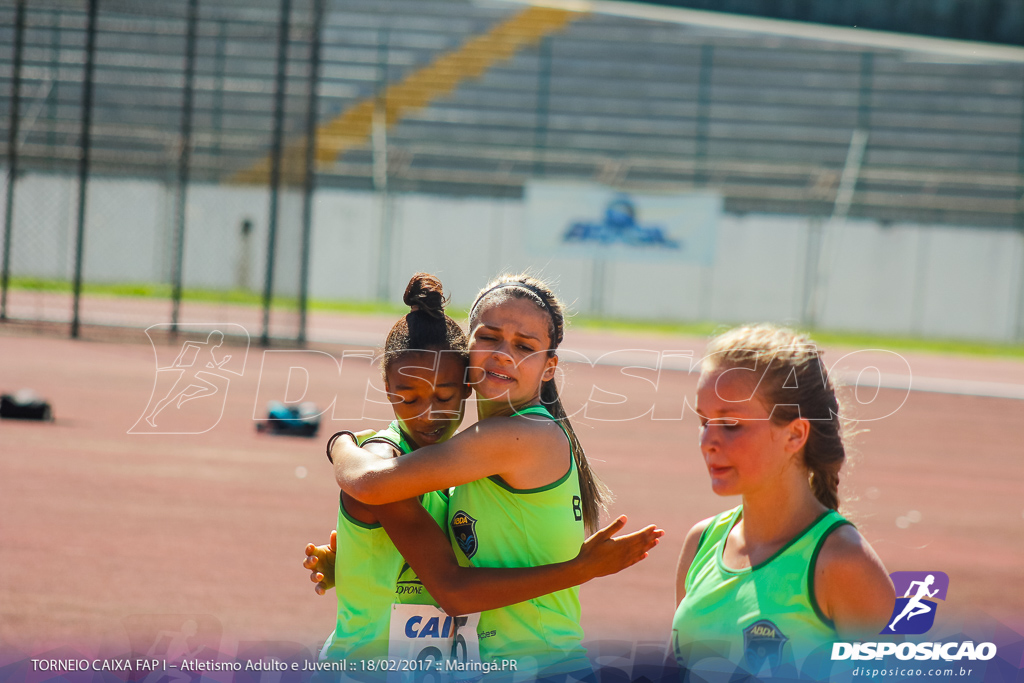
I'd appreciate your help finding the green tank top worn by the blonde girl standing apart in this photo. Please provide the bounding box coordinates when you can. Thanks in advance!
[672,506,850,680]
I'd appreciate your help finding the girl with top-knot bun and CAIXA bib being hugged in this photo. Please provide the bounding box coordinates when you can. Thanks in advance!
[315,273,660,675]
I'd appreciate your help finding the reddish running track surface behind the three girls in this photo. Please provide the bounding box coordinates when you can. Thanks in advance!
[0,302,1024,656]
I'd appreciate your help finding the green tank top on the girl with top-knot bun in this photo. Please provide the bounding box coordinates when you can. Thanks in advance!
[321,422,447,659]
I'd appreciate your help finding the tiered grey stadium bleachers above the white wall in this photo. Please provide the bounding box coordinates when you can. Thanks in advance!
[0,0,1024,227]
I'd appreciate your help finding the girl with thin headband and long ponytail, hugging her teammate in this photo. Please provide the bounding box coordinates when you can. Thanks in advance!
[333,275,647,678]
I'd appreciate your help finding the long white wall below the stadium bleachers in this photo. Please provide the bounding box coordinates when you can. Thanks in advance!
[0,174,1024,342]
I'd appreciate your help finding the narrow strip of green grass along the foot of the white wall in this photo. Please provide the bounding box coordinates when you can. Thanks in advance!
[10,278,1024,358]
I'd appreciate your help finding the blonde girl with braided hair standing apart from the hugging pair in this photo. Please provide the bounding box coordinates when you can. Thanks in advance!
[672,326,895,679]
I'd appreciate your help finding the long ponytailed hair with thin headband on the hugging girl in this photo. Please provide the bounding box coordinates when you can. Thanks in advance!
[469,274,611,532]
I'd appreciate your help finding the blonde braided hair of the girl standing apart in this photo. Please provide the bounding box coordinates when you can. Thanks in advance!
[701,325,846,510]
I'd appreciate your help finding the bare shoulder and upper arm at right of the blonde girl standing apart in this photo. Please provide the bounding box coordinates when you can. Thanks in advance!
[813,524,896,635]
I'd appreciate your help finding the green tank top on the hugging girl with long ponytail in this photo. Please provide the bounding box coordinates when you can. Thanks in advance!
[449,405,590,675]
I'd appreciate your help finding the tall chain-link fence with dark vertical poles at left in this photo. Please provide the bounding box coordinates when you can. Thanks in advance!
[0,0,324,339]
